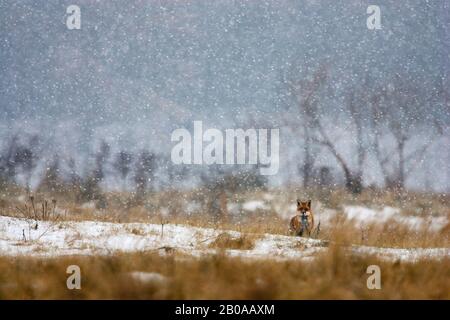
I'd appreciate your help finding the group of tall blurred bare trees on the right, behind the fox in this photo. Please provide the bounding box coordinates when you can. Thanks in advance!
[282,65,449,193]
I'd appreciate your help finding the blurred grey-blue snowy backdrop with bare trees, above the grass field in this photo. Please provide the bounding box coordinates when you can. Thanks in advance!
[0,0,450,196]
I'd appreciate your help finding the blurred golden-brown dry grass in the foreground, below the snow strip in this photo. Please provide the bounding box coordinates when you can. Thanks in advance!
[0,247,450,299]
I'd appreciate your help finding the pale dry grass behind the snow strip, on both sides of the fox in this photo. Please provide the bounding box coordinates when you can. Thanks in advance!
[0,187,450,248]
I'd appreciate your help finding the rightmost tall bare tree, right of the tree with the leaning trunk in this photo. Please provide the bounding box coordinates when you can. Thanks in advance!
[371,75,441,189]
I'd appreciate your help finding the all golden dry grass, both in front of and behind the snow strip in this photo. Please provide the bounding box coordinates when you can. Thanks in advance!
[0,185,450,299]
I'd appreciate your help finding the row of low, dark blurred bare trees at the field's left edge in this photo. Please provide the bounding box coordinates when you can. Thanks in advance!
[0,134,161,200]
